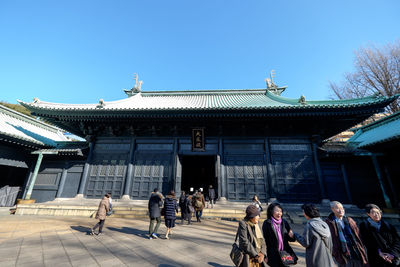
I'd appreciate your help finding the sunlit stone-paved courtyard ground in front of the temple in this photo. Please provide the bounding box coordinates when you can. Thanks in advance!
[0,215,305,267]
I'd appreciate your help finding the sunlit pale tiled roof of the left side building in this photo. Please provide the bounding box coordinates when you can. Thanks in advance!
[0,105,68,147]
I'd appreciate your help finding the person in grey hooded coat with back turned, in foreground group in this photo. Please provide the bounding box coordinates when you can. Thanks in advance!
[289,204,336,267]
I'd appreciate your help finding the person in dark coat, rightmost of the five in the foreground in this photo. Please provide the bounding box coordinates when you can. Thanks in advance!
[360,204,400,267]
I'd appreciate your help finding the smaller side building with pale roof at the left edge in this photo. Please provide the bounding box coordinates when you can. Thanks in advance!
[0,105,88,206]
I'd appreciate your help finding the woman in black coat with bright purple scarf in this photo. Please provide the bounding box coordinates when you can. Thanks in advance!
[262,203,298,267]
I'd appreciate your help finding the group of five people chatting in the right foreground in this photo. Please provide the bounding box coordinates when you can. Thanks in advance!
[237,201,400,267]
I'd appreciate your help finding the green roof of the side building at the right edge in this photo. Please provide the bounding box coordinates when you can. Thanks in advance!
[348,111,400,148]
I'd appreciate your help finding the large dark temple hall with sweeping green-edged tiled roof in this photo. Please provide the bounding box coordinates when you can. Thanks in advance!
[13,78,397,208]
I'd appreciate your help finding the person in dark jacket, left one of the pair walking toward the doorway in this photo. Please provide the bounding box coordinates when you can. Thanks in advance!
[148,188,164,239]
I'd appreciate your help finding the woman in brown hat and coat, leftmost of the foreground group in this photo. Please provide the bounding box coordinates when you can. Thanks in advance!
[237,205,267,267]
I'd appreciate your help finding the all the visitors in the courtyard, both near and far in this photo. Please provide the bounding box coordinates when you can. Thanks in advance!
[90,192,400,267]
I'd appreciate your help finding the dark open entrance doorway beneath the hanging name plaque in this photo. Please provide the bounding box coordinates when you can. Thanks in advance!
[181,156,218,197]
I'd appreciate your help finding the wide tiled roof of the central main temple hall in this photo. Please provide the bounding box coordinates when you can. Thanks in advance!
[19,89,398,117]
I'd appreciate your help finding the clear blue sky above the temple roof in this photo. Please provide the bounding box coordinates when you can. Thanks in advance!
[0,0,400,103]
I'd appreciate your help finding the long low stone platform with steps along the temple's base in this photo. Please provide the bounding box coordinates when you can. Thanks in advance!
[16,198,400,230]
